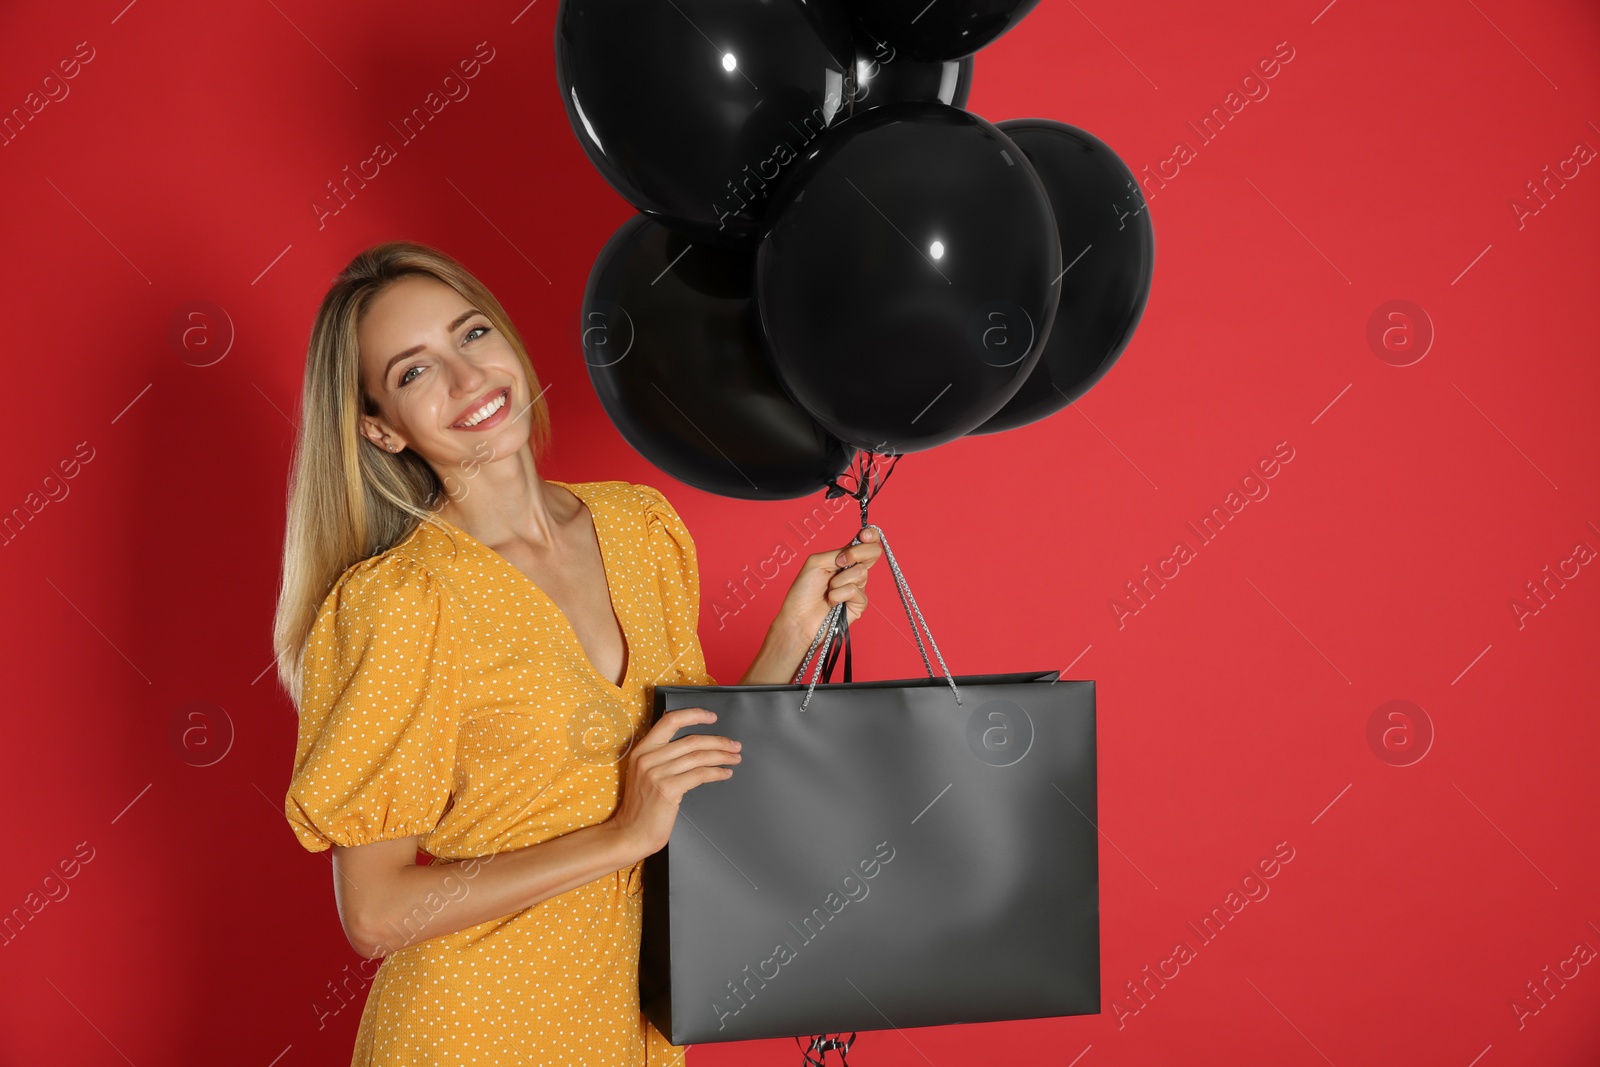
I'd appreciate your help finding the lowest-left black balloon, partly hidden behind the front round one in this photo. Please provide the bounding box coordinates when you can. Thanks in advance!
[582,214,854,501]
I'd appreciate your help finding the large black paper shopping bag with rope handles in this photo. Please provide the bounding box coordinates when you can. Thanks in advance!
[640,530,1101,1045]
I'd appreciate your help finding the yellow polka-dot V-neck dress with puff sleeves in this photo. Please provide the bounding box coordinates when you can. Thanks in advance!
[285,480,715,1067]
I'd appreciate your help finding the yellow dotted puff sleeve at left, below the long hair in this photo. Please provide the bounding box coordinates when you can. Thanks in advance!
[285,557,461,853]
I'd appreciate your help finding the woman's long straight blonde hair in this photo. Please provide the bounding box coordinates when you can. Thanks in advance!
[272,242,550,705]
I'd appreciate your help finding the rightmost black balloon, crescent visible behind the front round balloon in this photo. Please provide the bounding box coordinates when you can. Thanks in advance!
[971,118,1155,434]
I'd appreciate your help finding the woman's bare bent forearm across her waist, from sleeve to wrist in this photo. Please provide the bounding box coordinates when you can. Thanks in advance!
[333,821,640,960]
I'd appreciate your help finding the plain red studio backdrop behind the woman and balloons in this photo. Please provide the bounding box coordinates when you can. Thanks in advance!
[0,0,1600,1067]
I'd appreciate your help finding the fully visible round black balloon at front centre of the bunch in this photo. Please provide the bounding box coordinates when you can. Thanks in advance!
[757,102,1061,453]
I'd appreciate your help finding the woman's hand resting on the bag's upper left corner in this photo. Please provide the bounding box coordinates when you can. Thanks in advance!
[610,707,742,857]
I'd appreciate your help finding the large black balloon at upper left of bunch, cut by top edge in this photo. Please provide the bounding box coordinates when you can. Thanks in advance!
[555,0,854,246]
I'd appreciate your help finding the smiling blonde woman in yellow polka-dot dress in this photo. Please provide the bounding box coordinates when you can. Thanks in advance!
[275,242,882,1067]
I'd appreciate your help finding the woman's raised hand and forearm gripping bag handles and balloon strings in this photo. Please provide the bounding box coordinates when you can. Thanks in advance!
[739,530,883,685]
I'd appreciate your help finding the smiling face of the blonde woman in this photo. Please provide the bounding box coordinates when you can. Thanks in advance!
[357,275,533,485]
